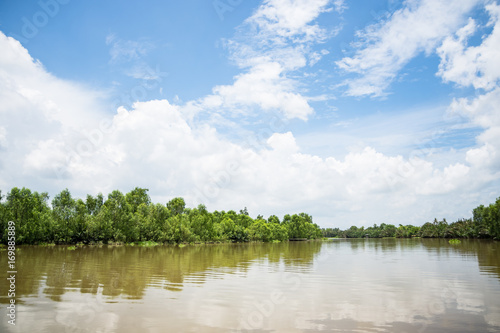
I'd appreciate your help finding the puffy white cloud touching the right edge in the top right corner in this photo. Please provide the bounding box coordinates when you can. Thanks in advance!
[437,4,500,90]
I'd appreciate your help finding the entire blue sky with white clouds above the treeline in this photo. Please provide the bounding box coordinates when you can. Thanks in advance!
[0,0,500,229]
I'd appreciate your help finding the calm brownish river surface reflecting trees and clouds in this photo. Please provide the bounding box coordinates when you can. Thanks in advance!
[0,239,500,333]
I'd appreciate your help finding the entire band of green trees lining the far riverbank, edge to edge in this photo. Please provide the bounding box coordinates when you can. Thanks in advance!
[0,187,500,244]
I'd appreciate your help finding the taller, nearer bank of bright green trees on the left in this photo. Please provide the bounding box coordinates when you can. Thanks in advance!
[0,187,322,244]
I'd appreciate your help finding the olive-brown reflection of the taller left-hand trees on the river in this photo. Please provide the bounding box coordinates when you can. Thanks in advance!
[0,242,321,302]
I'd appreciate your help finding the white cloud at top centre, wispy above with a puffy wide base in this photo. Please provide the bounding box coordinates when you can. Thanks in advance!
[195,0,336,120]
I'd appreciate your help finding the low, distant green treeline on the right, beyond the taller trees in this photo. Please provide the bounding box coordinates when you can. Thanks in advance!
[322,198,500,239]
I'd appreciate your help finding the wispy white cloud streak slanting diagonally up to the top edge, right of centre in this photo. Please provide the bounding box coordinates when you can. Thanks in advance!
[337,0,482,96]
